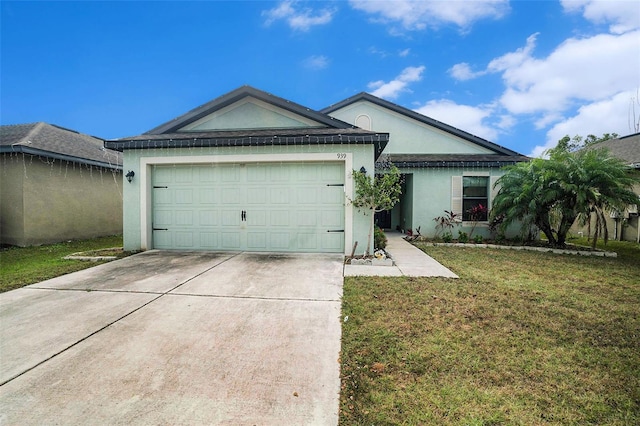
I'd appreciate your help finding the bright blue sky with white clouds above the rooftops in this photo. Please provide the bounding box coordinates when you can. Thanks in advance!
[0,0,640,155]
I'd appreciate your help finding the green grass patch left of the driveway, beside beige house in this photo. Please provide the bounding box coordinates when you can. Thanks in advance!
[0,235,122,292]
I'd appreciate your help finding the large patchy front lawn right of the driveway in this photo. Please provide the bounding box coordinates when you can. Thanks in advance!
[340,241,640,425]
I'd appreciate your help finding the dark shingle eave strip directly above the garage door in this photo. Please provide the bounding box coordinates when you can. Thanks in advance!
[104,127,389,158]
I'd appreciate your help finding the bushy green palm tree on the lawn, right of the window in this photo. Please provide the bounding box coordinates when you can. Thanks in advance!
[491,148,638,247]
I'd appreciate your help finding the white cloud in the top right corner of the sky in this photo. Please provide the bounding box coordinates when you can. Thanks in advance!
[560,0,640,34]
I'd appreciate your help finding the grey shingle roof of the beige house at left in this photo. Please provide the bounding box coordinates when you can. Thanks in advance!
[0,122,122,169]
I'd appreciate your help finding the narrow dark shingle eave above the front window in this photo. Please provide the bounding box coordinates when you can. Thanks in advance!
[389,154,530,167]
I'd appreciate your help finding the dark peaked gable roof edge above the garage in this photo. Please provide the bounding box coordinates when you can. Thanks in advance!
[145,86,354,135]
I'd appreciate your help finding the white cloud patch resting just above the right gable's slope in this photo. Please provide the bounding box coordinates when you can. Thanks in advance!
[415,99,498,140]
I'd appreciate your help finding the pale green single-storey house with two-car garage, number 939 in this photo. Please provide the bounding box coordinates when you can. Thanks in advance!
[105,86,527,253]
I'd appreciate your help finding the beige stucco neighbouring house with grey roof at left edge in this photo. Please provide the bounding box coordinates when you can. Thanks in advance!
[0,122,122,246]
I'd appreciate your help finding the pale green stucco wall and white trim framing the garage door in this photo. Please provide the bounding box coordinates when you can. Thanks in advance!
[123,144,374,253]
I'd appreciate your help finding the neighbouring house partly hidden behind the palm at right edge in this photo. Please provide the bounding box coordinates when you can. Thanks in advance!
[571,133,640,243]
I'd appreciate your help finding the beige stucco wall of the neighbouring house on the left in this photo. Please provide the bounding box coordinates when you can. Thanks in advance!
[0,154,122,246]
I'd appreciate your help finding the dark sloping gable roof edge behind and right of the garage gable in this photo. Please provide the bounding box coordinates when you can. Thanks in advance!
[320,92,522,157]
